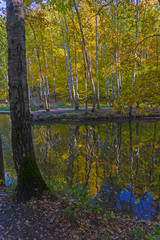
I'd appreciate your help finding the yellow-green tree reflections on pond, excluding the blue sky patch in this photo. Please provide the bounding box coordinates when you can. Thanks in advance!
[31,122,160,208]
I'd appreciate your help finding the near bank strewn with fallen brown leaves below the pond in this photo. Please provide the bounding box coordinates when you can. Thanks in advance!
[0,186,160,240]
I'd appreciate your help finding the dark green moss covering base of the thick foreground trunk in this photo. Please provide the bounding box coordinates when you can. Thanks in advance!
[16,158,47,201]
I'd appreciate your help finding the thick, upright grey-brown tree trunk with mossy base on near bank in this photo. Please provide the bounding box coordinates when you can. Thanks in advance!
[6,0,47,200]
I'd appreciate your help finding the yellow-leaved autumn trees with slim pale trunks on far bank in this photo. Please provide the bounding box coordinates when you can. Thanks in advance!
[0,0,160,109]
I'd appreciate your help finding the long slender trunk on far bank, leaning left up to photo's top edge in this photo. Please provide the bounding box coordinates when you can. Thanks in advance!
[73,0,96,111]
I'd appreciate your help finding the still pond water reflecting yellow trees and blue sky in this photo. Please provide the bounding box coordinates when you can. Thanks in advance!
[0,115,160,220]
